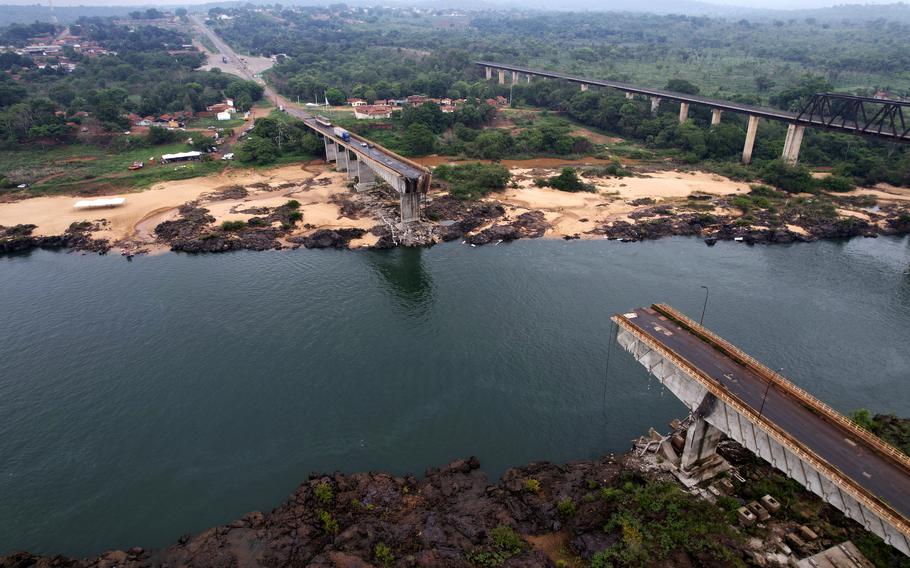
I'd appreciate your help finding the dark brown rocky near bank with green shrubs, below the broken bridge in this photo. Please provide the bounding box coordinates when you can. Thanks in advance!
[0,430,903,568]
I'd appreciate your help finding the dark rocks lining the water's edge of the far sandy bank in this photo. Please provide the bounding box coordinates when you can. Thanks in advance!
[0,183,910,254]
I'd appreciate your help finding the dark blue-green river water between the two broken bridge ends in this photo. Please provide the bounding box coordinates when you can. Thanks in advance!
[0,238,910,555]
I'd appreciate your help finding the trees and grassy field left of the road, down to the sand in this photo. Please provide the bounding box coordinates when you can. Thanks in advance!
[0,18,262,193]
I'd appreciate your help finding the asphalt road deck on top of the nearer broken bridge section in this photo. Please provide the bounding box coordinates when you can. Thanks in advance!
[620,308,910,519]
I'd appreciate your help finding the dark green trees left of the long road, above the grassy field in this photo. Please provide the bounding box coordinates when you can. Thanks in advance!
[0,18,262,147]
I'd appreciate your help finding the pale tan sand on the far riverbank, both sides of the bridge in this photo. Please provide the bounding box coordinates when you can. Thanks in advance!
[0,161,910,250]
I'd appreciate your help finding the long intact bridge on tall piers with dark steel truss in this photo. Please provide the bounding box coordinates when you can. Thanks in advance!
[474,61,910,164]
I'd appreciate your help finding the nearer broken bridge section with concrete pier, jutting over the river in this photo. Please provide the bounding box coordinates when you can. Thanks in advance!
[613,304,910,555]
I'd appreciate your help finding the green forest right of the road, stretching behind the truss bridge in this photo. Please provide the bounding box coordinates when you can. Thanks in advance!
[209,5,910,185]
